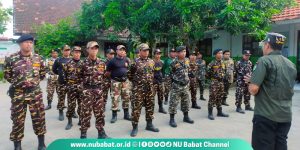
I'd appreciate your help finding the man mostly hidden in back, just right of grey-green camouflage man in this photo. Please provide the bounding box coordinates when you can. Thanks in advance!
[196,52,206,101]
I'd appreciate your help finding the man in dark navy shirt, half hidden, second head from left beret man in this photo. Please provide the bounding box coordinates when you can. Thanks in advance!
[52,45,71,121]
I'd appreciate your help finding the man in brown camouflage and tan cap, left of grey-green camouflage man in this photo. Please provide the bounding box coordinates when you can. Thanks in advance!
[128,43,159,137]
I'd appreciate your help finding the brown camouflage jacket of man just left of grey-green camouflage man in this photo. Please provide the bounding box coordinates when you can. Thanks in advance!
[128,58,155,86]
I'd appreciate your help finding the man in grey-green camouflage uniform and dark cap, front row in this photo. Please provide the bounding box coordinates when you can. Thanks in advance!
[169,46,194,128]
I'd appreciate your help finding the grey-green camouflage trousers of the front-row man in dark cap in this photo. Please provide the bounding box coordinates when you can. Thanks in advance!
[169,83,190,114]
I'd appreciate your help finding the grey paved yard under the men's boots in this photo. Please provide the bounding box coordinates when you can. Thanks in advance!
[0,81,300,150]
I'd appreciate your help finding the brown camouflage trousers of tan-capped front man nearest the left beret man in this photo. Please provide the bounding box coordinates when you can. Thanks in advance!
[80,89,105,132]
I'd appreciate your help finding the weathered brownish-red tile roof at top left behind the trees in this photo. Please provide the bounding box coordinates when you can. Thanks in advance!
[13,0,84,35]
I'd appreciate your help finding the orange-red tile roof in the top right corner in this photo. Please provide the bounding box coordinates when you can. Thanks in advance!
[272,0,300,21]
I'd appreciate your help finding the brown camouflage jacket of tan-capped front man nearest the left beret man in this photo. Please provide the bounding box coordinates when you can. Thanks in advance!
[81,57,105,88]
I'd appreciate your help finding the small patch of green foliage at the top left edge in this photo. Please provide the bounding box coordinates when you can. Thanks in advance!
[0,1,13,34]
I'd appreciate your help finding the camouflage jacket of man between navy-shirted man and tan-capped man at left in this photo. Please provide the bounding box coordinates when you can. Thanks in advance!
[64,59,82,85]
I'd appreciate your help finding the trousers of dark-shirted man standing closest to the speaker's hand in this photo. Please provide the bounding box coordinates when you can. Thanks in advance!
[235,84,251,106]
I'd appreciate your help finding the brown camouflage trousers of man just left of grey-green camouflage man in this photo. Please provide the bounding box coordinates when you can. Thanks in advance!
[131,85,155,124]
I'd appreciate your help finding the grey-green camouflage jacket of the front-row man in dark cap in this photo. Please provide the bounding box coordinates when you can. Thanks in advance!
[171,58,190,86]
